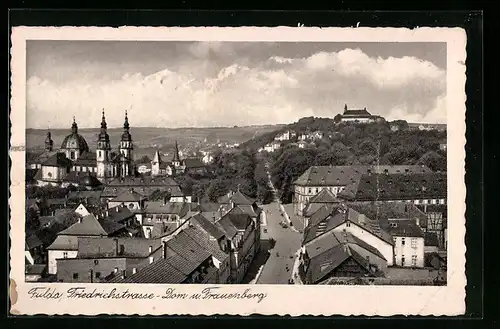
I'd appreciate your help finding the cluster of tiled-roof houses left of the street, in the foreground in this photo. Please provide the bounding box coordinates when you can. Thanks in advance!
[25,191,261,283]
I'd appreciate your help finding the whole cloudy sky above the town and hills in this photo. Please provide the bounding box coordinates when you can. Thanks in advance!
[26,41,446,129]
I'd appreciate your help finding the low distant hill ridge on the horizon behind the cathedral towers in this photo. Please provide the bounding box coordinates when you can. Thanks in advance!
[26,125,288,156]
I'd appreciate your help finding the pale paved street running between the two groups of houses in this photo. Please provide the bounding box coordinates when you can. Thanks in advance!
[257,202,302,284]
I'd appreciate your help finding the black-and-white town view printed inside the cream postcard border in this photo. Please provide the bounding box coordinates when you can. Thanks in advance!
[9,27,465,316]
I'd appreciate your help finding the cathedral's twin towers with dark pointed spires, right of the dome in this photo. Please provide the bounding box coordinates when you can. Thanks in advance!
[96,110,135,180]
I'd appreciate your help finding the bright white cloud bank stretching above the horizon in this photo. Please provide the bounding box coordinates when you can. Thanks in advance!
[27,47,446,128]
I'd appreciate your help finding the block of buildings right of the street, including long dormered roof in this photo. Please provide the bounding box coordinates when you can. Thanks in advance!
[294,166,447,284]
